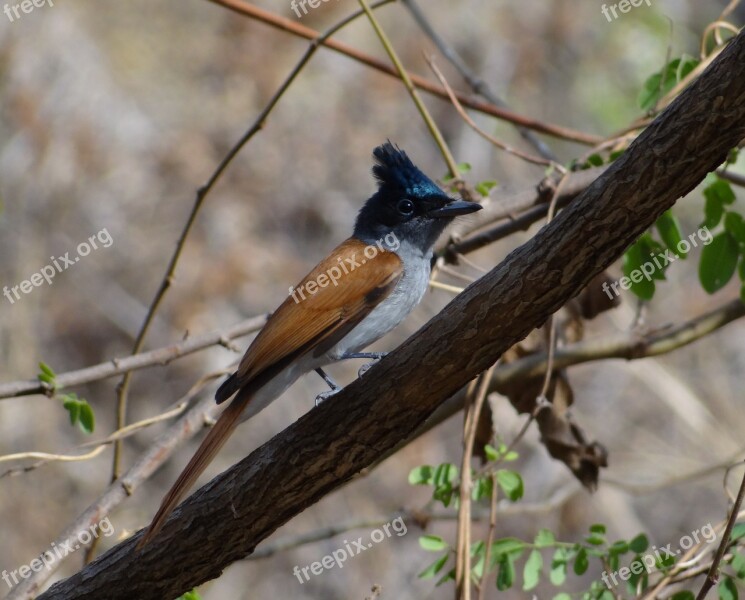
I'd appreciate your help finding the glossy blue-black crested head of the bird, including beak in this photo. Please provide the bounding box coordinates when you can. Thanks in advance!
[354,142,481,252]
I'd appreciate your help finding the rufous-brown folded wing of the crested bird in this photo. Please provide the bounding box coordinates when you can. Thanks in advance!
[236,238,403,387]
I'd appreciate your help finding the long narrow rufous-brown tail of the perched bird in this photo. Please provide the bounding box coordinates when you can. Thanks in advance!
[137,389,254,550]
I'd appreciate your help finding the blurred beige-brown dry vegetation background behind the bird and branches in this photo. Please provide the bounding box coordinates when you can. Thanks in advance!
[0,0,745,600]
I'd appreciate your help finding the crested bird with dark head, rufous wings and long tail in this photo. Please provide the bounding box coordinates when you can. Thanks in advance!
[138,140,482,548]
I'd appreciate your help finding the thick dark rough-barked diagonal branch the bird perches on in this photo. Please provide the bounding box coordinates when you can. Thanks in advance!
[41,33,745,600]
